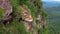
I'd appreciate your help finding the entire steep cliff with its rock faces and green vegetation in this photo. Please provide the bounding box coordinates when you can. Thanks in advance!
[0,0,48,34]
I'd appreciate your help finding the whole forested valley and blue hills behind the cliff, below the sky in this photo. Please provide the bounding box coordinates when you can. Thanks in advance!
[43,2,60,34]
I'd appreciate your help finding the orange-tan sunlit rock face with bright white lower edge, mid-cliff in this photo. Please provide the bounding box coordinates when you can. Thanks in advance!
[19,6,33,22]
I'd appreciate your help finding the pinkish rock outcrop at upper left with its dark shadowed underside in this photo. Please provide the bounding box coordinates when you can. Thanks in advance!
[0,0,13,22]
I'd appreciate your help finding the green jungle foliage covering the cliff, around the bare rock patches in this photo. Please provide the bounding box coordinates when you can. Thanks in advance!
[0,0,48,34]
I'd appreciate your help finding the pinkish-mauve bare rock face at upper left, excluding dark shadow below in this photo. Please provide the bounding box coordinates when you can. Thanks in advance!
[0,0,12,17]
